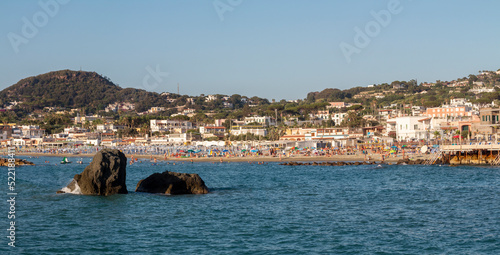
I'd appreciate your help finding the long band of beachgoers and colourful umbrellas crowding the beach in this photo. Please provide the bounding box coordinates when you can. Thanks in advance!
[5,145,432,161]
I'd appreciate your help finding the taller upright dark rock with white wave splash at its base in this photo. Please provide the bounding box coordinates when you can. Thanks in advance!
[58,149,128,196]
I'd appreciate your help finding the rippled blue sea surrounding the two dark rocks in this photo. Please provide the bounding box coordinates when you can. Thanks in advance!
[0,157,500,254]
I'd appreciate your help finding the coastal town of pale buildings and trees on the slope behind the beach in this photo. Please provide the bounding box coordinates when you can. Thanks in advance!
[0,70,500,161]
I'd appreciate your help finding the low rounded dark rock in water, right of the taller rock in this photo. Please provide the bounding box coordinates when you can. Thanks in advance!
[135,171,208,195]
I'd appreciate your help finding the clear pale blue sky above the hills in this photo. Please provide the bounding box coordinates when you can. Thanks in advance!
[0,0,500,100]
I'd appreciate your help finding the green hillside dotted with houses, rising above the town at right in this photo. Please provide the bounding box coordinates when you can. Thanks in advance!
[307,70,500,108]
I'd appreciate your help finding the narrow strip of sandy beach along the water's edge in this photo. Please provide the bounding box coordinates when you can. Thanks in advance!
[16,153,430,163]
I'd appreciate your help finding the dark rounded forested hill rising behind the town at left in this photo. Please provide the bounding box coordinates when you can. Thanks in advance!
[0,70,165,111]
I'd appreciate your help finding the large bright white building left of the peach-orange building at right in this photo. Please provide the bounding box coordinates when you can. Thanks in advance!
[387,116,432,141]
